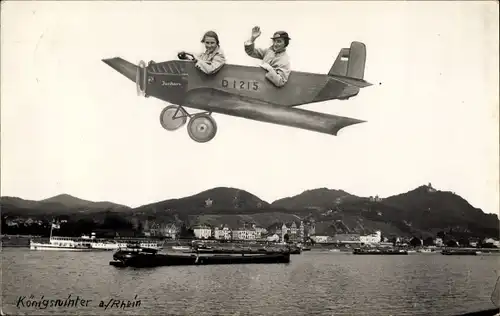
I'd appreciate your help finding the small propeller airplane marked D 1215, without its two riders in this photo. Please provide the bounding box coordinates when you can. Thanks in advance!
[102,42,372,143]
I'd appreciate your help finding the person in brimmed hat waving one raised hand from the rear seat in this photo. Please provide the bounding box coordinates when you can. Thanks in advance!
[245,26,291,87]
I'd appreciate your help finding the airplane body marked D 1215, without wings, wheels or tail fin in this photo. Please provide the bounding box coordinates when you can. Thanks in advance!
[145,60,359,108]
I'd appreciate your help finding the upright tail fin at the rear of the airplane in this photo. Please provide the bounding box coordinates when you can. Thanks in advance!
[328,42,371,88]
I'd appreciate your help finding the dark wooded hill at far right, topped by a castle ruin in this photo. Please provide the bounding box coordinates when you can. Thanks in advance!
[298,186,500,237]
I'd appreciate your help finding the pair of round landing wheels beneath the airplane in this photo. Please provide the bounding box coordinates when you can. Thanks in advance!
[160,105,217,143]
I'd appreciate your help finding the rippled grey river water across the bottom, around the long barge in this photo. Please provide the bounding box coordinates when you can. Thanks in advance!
[1,248,500,316]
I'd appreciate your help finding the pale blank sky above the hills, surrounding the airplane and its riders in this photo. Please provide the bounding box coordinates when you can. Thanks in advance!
[0,1,499,214]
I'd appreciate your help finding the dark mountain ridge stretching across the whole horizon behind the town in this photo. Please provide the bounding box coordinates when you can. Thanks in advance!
[0,185,500,236]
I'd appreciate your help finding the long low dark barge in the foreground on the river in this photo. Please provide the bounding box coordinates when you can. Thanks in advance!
[109,247,290,268]
